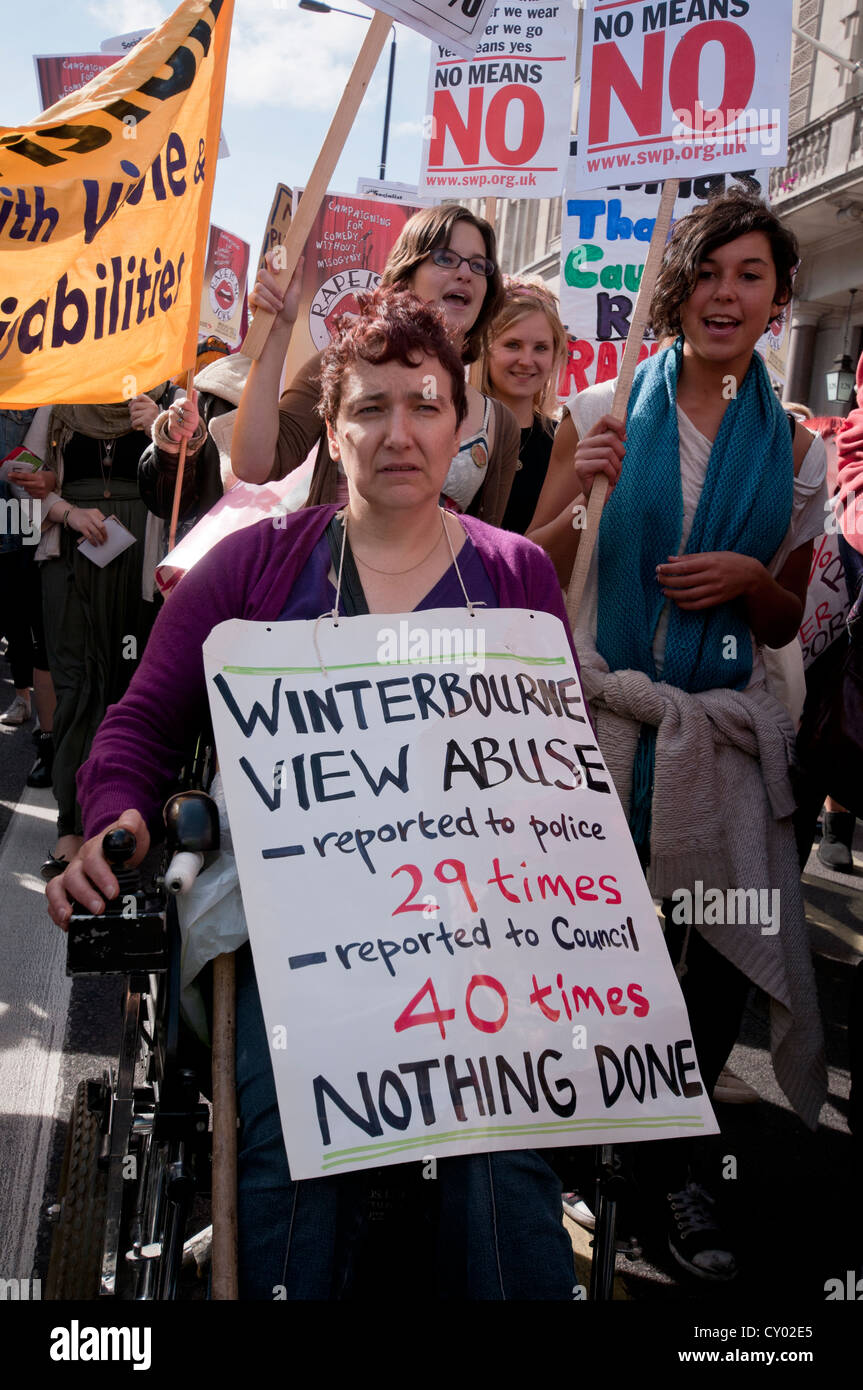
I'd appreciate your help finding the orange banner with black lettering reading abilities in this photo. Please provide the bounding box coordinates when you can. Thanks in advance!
[0,0,233,409]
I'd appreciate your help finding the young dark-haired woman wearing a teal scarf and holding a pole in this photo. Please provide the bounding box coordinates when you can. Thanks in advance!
[528,192,825,1280]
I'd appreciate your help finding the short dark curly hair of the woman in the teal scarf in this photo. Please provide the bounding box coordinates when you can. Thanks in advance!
[650,188,800,338]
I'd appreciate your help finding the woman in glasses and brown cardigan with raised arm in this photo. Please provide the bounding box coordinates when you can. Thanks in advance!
[231,203,518,525]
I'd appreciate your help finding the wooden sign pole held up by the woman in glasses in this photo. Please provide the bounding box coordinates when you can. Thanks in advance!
[243,10,392,360]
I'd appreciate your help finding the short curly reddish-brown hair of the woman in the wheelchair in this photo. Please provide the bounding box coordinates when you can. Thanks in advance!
[317,288,467,428]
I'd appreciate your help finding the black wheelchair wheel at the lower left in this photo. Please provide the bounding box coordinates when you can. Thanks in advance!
[46,1081,108,1298]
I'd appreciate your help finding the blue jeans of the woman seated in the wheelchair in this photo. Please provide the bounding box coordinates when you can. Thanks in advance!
[236,945,574,1300]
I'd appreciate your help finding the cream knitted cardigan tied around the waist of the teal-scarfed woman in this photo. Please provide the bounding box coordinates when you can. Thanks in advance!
[574,628,827,1129]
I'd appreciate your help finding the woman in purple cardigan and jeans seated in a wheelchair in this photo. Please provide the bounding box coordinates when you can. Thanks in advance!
[47,291,573,1300]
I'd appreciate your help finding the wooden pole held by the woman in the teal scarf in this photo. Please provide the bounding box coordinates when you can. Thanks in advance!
[567,178,680,630]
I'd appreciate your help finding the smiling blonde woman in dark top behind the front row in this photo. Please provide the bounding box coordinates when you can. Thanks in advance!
[481,275,567,535]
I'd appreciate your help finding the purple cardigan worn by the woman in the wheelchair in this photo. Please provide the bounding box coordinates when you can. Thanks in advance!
[78,506,574,840]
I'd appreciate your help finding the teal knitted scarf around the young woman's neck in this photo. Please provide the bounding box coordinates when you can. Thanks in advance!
[596,338,794,840]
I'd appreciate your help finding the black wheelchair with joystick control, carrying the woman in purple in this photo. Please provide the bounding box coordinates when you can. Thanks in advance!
[46,790,218,1301]
